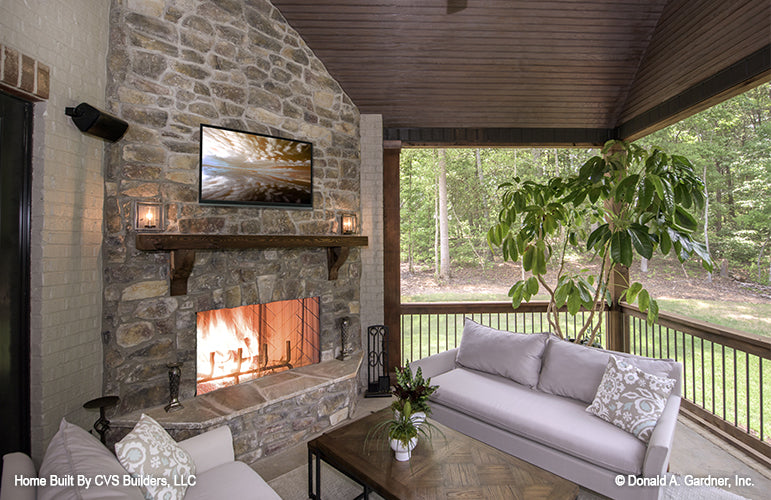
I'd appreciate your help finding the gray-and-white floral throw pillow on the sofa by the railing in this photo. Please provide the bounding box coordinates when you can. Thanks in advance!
[586,356,675,443]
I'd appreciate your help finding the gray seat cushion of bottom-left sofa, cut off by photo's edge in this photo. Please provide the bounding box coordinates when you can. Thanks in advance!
[185,462,281,500]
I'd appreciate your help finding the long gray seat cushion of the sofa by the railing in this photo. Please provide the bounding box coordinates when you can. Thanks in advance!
[431,368,646,474]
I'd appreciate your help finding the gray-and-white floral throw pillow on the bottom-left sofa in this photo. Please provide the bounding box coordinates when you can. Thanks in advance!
[115,414,195,500]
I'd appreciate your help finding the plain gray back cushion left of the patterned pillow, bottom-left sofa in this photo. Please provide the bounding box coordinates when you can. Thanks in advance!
[37,419,144,500]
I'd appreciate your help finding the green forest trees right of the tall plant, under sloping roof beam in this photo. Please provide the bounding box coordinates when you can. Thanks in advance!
[638,84,771,284]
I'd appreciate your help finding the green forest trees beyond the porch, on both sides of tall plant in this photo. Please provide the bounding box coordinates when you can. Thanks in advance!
[401,84,771,284]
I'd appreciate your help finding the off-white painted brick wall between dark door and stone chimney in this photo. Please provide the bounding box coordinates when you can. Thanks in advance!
[0,0,109,461]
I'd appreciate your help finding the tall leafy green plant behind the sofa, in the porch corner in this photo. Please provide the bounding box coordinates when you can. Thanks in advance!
[487,141,712,345]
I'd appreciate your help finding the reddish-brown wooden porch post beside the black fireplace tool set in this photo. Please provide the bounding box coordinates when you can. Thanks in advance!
[383,141,402,373]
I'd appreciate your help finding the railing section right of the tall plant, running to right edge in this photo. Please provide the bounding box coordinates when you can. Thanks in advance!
[621,304,771,456]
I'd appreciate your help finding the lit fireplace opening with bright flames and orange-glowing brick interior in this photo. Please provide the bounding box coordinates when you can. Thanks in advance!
[196,297,320,395]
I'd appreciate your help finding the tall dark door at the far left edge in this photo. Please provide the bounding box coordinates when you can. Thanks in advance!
[0,92,32,455]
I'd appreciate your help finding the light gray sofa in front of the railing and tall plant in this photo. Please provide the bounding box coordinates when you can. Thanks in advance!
[410,319,682,500]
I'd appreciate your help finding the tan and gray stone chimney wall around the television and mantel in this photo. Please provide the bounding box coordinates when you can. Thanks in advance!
[102,0,361,412]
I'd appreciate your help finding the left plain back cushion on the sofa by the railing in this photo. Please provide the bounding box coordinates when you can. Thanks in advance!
[456,318,548,387]
